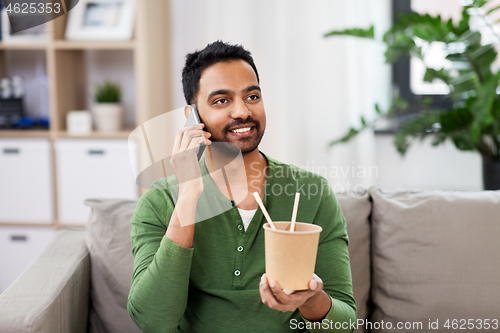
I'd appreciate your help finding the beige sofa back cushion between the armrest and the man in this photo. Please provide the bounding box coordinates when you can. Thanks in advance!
[85,199,140,333]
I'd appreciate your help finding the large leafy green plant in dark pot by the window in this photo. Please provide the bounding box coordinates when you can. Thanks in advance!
[325,0,500,190]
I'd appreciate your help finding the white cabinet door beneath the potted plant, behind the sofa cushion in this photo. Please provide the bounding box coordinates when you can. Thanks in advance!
[56,139,138,225]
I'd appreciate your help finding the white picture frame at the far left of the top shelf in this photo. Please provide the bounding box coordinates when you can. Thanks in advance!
[0,7,49,44]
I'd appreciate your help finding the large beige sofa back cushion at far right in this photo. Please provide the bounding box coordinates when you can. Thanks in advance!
[370,188,500,332]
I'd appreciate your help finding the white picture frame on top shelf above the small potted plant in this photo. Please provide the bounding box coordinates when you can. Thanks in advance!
[65,0,137,41]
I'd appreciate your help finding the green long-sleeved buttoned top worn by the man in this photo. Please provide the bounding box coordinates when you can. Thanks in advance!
[127,155,356,333]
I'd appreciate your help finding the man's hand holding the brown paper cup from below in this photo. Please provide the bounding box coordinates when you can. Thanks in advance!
[259,274,331,321]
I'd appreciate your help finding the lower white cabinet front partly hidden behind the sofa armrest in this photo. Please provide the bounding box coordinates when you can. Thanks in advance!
[0,227,55,293]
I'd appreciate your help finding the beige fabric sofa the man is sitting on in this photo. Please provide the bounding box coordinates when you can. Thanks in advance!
[0,187,500,333]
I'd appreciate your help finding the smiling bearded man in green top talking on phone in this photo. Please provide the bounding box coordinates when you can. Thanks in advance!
[128,41,356,333]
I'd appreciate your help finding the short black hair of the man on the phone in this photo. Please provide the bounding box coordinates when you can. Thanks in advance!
[182,40,259,104]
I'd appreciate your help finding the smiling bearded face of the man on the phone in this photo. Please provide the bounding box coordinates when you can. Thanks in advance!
[196,60,266,154]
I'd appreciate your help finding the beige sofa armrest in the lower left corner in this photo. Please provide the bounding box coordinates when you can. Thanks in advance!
[0,230,90,333]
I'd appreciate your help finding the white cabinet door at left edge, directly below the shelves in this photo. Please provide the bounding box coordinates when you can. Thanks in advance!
[0,139,54,224]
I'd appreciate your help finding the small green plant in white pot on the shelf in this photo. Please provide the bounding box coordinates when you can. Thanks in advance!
[92,81,123,132]
